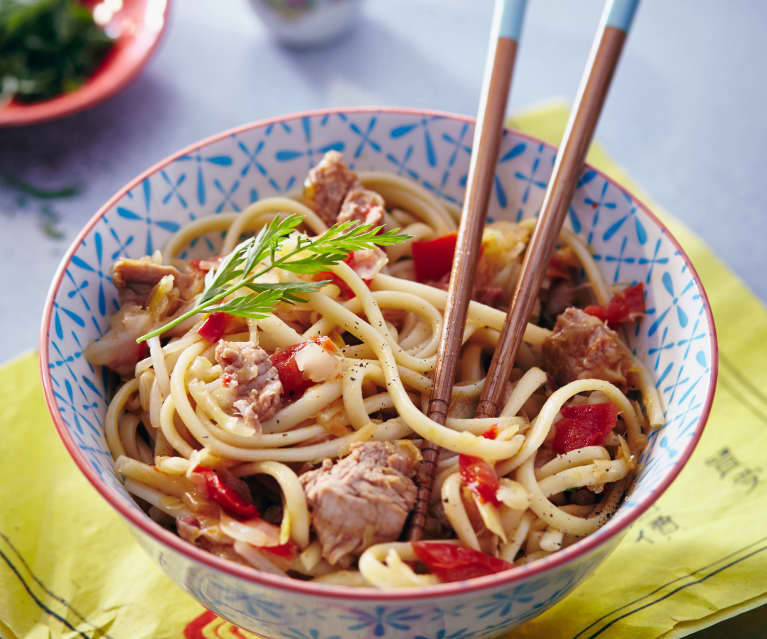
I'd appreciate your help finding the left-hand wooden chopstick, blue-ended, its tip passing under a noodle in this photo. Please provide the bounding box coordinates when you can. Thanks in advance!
[409,0,527,541]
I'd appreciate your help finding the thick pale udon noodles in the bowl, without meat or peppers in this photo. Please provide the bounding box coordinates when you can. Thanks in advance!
[99,172,662,587]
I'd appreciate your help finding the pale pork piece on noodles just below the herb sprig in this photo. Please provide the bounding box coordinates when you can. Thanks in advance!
[216,340,282,433]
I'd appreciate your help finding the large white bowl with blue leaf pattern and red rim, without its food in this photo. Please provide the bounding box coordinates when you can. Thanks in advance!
[40,108,717,639]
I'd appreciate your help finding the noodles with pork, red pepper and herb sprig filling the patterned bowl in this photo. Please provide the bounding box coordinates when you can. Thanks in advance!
[85,151,664,588]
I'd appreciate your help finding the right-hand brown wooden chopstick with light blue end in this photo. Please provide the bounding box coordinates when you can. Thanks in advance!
[476,0,639,417]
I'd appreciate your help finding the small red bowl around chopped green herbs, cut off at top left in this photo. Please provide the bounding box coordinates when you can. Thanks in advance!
[0,0,170,127]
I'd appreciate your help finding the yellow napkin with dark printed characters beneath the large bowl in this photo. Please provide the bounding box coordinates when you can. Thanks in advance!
[0,105,767,639]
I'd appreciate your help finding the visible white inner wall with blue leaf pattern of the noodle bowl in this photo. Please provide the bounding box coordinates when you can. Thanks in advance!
[43,110,712,544]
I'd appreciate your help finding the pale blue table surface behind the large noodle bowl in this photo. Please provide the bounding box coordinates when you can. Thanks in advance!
[0,0,767,632]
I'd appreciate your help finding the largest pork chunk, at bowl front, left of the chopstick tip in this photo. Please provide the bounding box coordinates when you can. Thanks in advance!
[300,442,417,565]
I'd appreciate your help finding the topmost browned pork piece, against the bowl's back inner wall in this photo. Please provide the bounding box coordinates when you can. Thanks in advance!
[304,151,359,226]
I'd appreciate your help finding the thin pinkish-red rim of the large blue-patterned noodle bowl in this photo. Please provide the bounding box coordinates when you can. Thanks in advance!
[39,106,719,602]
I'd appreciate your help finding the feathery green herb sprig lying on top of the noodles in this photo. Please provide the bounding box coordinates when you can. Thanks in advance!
[136,215,411,342]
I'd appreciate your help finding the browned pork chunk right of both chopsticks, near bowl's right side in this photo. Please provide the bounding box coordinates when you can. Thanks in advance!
[543,307,631,390]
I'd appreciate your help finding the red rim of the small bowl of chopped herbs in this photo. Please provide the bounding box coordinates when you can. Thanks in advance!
[0,0,171,129]
